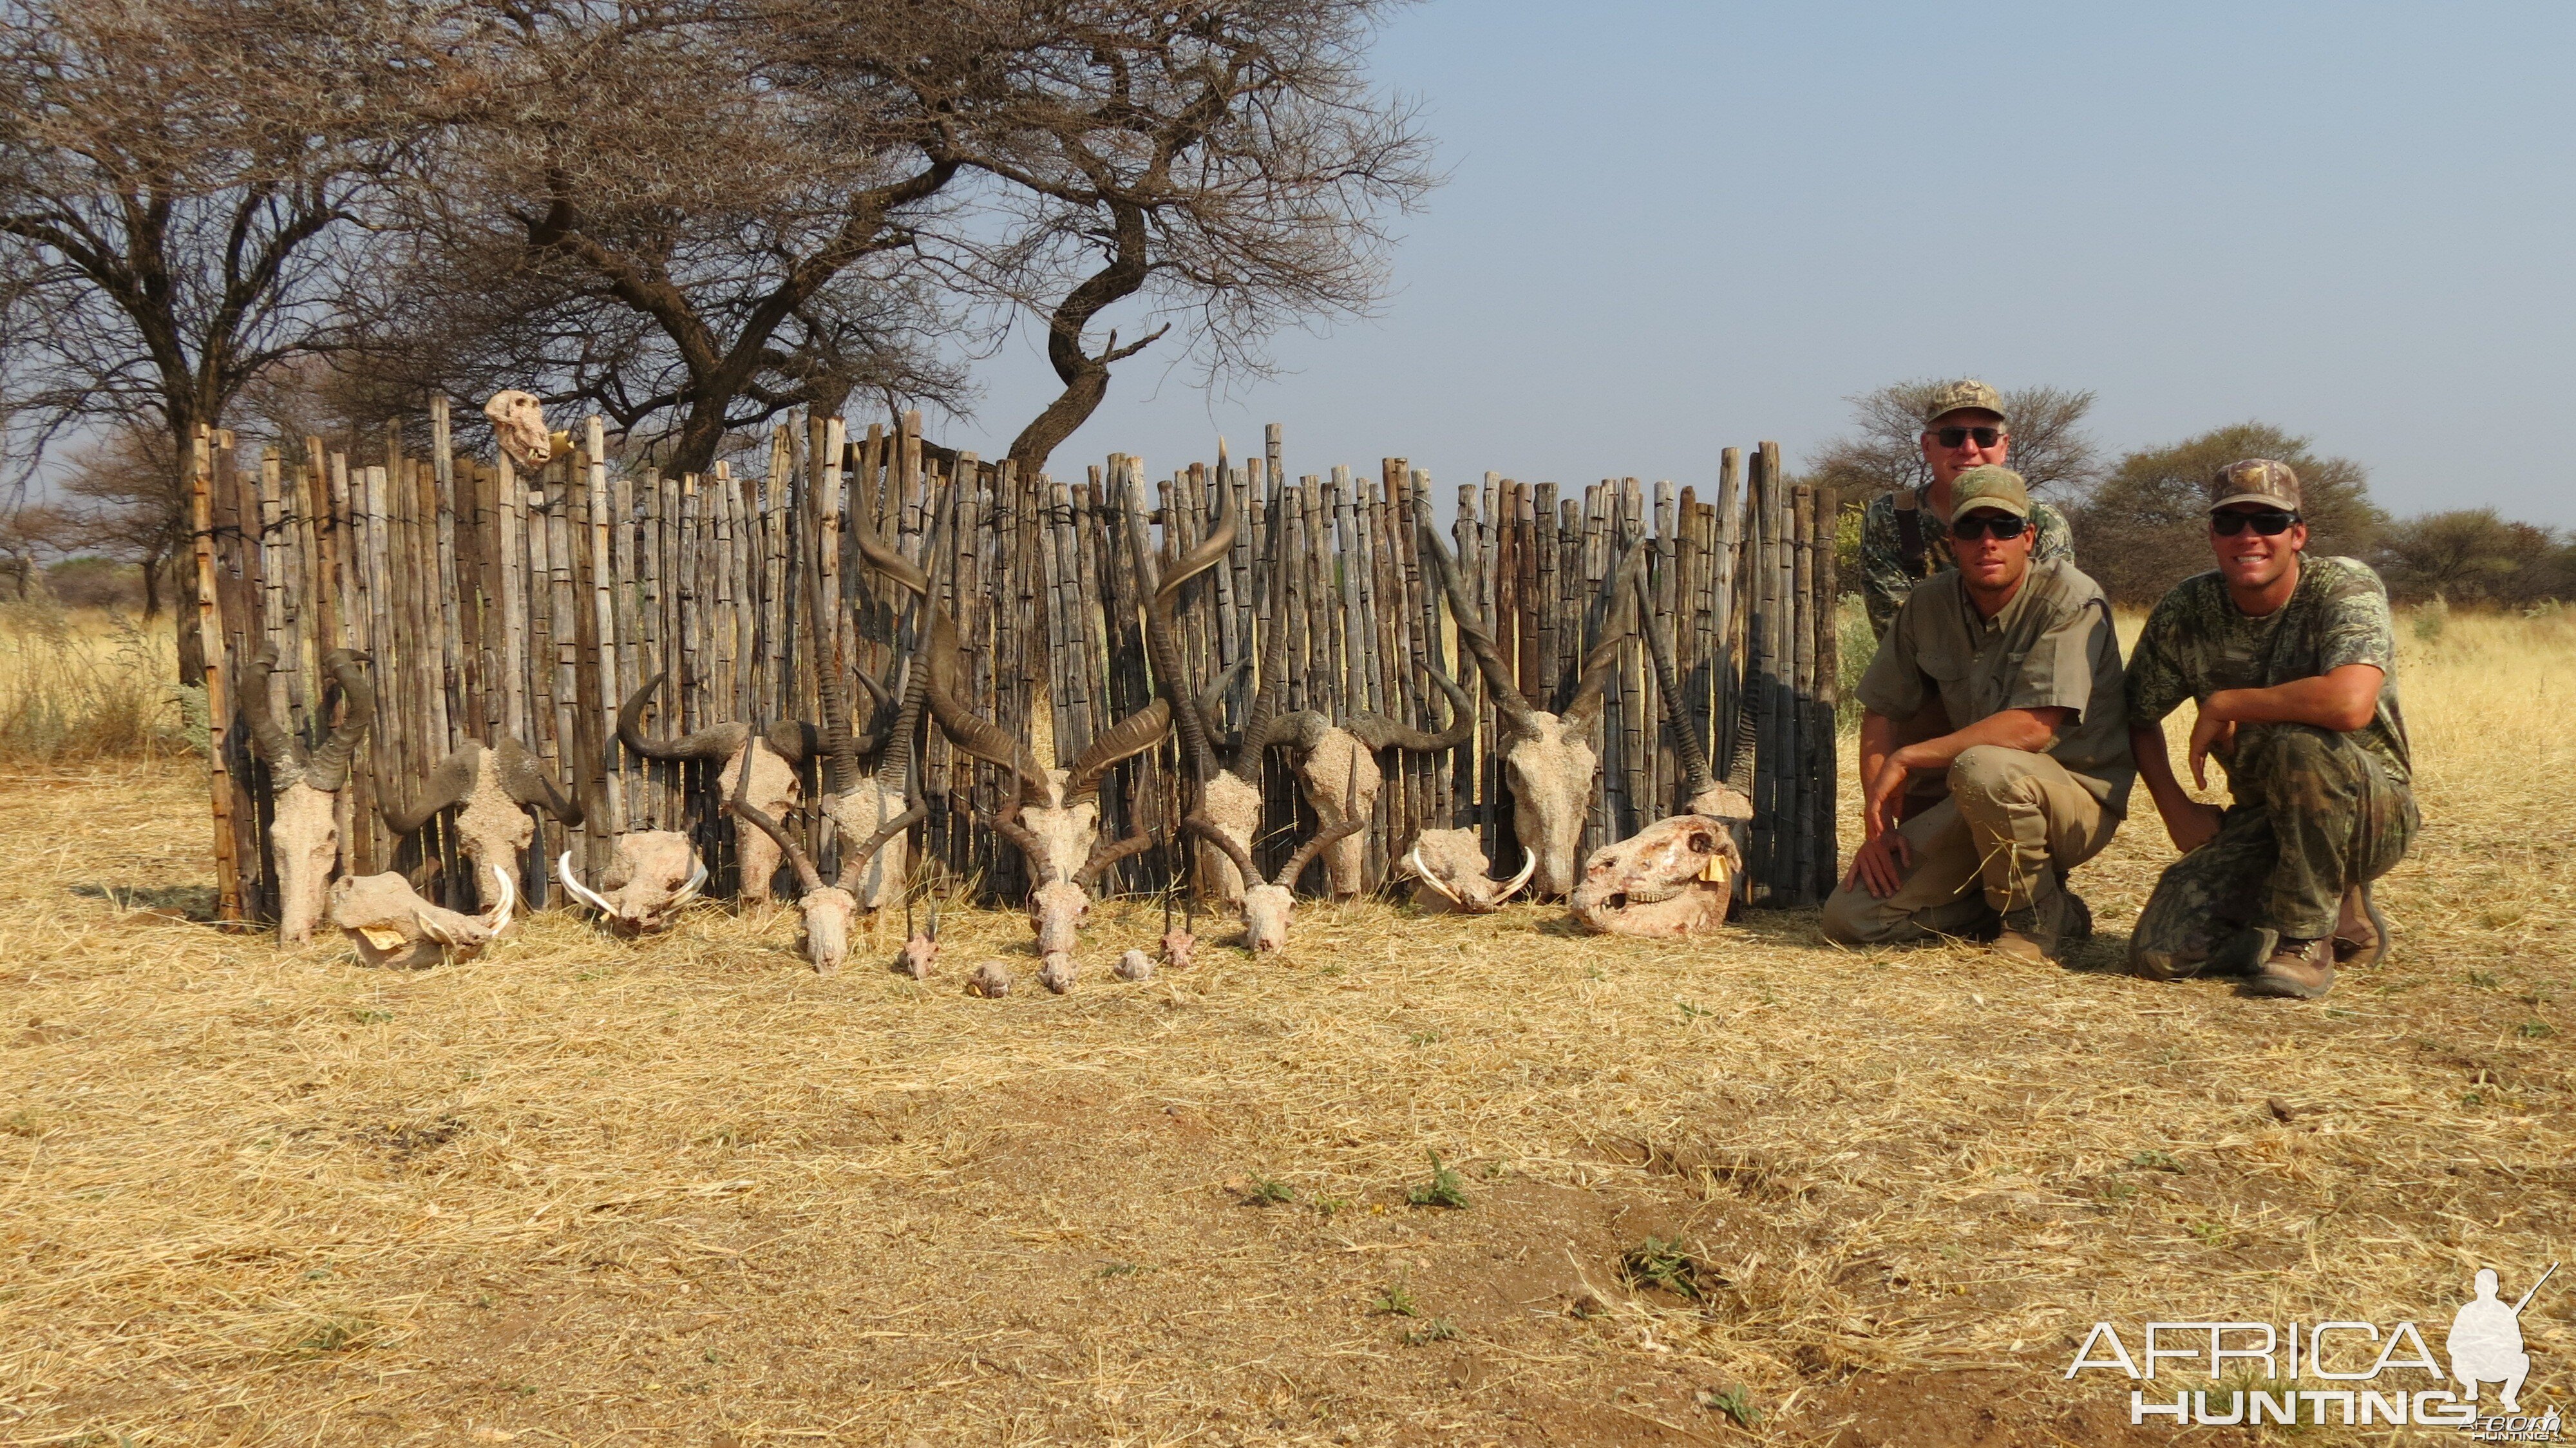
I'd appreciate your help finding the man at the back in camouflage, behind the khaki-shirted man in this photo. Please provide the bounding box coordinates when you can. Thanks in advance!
[1860,376,2076,636]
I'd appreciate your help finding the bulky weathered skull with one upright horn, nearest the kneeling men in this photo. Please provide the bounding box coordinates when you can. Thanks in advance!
[1571,567,1754,938]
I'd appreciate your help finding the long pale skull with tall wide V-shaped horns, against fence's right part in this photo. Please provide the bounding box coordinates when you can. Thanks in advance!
[1414,505,1646,899]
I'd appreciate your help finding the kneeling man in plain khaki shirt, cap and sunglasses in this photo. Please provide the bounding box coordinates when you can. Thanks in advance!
[1824,466,2136,961]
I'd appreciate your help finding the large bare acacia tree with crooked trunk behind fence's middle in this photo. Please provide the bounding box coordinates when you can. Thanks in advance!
[402,0,1430,469]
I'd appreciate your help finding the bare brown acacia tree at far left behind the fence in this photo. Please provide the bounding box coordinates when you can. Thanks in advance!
[0,0,399,484]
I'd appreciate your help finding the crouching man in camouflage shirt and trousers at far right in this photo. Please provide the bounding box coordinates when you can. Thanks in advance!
[2128,459,2416,1000]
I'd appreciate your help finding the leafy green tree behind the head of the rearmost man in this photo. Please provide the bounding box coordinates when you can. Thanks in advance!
[1806,379,2102,508]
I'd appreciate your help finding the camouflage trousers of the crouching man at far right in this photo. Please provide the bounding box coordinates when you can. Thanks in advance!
[2128,724,2416,976]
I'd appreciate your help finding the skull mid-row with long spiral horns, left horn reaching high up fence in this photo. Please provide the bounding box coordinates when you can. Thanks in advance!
[850,474,1180,969]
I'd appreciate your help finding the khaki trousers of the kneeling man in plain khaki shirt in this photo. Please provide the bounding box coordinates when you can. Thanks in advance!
[1824,745,2120,946]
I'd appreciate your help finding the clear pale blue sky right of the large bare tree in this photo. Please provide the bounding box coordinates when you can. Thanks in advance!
[958,0,2576,526]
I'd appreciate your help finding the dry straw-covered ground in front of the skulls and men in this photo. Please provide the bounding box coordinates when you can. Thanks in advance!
[0,603,2576,1445]
